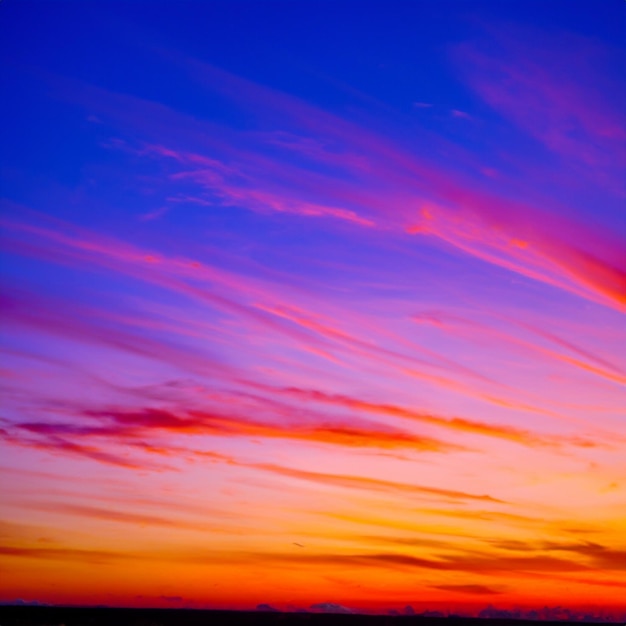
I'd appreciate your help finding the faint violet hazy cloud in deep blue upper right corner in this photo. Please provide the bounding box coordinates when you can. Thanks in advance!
[455,24,626,183]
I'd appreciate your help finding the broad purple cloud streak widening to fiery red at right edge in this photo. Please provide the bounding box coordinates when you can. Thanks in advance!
[42,45,626,310]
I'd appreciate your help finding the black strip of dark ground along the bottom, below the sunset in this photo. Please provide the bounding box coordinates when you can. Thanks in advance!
[0,606,616,626]
